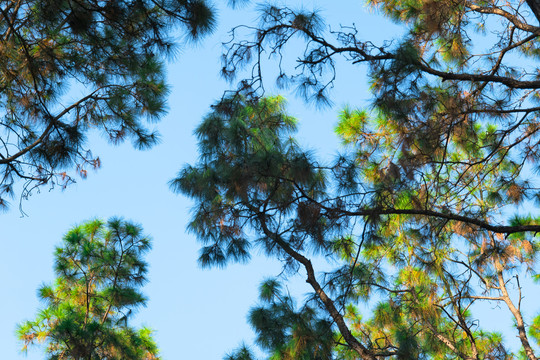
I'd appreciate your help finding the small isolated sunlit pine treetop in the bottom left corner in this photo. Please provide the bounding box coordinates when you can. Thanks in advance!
[17,218,159,360]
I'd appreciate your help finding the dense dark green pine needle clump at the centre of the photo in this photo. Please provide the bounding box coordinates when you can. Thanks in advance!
[171,97,326,266]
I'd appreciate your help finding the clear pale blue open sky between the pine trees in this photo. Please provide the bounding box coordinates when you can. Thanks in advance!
[0,0,536,360]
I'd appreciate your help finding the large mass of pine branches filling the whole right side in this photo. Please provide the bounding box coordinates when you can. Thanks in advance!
[171,0,540,360]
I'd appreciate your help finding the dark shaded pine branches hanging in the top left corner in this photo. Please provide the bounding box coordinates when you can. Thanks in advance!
[0,0,214,210]
